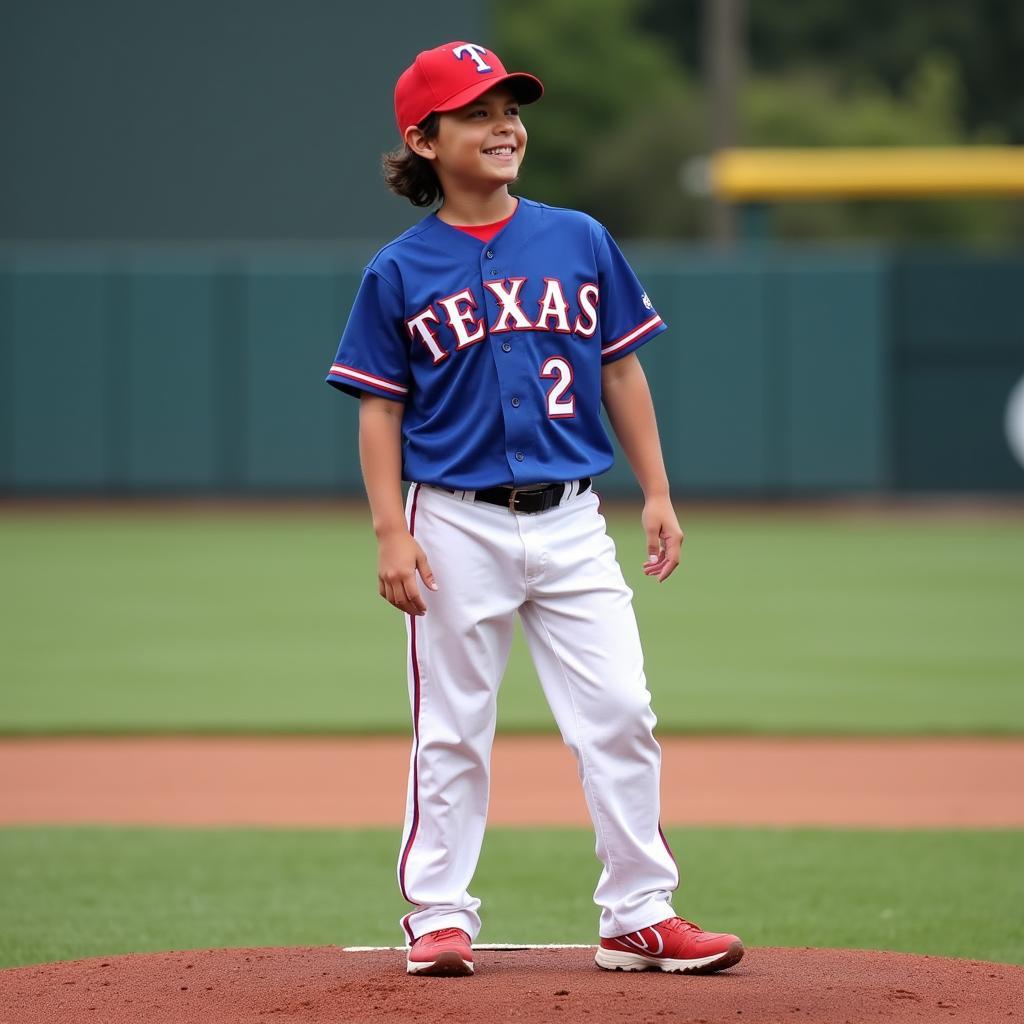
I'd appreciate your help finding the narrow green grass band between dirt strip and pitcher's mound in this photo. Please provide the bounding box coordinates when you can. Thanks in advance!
[0,828,1024,967]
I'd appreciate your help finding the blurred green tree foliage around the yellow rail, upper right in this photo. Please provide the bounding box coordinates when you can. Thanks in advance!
[494,0,1024,241]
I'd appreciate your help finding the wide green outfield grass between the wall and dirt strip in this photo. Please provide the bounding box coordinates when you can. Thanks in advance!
[0,509,1024,734]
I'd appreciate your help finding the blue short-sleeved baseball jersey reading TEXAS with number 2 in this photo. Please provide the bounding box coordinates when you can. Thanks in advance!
[327,199,666,490]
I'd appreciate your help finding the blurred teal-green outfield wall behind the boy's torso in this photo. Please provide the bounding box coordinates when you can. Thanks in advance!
[0,244,1024,497]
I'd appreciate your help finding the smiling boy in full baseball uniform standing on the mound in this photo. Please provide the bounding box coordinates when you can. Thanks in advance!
[327,42,743,975]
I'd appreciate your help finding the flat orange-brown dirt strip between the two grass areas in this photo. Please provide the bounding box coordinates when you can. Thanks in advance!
[0,736,1024,828]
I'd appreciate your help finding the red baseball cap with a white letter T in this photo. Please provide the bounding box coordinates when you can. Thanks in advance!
[394,42,544,135]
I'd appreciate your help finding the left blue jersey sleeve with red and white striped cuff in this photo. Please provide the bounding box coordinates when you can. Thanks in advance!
[327,268,410,401]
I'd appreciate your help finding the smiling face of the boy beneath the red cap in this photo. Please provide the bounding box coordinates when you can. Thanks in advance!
[414,85,526,193]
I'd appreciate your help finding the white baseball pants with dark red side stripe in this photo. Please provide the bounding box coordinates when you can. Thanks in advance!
[398,484,679,942]
